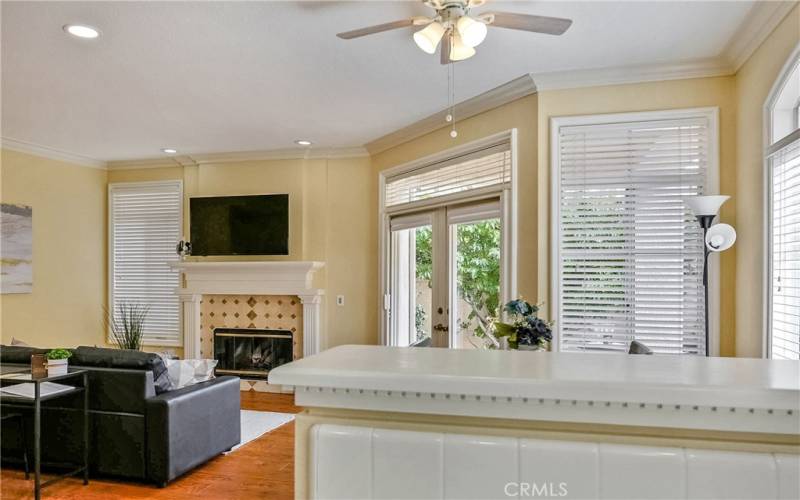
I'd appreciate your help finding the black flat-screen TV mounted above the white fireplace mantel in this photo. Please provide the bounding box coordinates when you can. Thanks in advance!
[189,194,289,255]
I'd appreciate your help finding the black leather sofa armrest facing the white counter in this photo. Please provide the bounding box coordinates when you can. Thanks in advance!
[146,376,241,485]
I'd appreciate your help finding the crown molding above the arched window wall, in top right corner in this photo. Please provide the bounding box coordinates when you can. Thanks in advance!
[722,1,798,73]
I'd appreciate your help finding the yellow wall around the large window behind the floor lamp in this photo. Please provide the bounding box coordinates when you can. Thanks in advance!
[536,76,738,356]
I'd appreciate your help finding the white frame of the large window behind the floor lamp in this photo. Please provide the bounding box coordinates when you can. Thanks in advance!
[550,107,720,356]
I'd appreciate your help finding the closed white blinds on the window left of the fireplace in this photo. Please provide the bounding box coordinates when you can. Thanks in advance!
[109,181,183,345]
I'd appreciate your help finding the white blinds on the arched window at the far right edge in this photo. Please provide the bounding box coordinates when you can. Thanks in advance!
[769,140,800,359]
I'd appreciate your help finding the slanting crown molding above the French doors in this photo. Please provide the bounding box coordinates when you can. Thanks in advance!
[364,74,537,155]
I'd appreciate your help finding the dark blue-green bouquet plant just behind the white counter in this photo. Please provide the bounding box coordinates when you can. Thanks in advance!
[492,299,553,351]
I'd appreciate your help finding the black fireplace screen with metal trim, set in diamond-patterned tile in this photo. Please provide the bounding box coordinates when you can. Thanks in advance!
[214,328,292,378]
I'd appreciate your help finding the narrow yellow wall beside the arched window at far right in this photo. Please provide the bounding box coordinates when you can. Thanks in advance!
[735,3,800,357]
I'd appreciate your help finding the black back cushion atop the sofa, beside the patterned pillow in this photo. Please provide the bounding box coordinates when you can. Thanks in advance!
[69,346,172,394]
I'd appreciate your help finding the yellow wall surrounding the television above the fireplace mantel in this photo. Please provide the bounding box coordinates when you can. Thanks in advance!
[108,157,377,347]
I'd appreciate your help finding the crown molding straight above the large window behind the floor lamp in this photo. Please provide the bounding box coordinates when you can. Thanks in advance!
[534,57,733,92]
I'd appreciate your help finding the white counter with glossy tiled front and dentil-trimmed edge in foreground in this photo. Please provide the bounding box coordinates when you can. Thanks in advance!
[269,346,800,499]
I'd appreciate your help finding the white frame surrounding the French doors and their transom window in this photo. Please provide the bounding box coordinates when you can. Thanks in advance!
[378,128,518,345]
